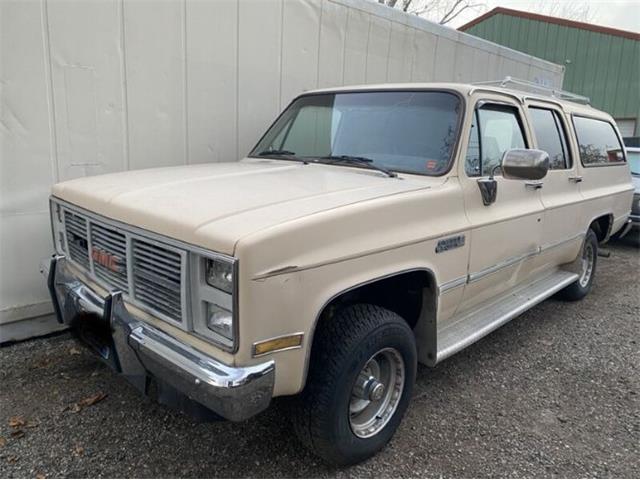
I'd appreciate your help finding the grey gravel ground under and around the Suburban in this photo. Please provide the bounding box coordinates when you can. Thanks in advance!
[0,238,640,477]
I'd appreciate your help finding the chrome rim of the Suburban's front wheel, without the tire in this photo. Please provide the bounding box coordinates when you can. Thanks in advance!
[349,348,405,438]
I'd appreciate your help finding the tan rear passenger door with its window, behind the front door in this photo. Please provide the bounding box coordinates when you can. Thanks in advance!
[526,101,584,269]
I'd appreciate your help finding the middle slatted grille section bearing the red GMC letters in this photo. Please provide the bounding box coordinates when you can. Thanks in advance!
[91,223,129,293]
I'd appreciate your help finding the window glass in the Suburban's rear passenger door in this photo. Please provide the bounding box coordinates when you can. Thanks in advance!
[529,107,571,170]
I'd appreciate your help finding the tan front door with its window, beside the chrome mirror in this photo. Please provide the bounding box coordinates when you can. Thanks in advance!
[459,95,544,312]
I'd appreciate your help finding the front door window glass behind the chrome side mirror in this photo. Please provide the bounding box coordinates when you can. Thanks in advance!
[465,105,526,176]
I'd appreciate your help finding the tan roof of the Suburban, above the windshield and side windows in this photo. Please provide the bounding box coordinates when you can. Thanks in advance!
[304,82,611,119]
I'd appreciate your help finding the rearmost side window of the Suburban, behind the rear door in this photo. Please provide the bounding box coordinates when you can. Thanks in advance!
[573,116,625,167]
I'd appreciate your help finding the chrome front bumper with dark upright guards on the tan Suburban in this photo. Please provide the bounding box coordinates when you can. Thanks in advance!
[41,256,275,421]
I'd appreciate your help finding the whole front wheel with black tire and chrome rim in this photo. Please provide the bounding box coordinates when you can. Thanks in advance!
[293,304,417,465]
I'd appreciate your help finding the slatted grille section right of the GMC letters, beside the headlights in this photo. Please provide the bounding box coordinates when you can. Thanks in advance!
[133,239,182,321]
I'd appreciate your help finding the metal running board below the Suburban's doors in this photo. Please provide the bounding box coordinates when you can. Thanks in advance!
[435,270,578,363]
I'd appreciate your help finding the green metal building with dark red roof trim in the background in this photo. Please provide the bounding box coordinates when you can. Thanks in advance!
[459,7,640,137]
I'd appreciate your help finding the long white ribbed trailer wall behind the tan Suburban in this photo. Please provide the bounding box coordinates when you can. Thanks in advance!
[0,0,564,342]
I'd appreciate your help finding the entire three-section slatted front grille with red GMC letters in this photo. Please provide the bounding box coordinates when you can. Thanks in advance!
[64,207,186,323]
